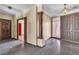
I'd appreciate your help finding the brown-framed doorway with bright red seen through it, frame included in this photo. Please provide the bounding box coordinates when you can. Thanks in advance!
[17,17,27,43]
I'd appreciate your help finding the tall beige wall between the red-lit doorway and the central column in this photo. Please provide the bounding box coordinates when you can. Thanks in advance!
[27,6,36,45]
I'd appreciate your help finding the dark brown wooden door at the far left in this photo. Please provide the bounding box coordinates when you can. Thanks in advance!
[1,20,11,39]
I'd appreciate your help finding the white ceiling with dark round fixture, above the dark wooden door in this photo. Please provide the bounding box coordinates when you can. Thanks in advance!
[0,4,34,15]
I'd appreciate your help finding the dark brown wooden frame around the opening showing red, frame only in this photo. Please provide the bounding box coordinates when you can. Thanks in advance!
[17,17,27,43]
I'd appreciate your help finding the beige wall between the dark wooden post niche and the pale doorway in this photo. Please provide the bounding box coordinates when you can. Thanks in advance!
[43,13,51,40]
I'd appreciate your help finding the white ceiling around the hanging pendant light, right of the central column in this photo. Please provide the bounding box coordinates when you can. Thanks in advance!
[43,4,79,16]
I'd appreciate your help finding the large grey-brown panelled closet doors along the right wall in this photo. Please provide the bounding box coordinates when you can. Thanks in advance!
[61,13,79,42]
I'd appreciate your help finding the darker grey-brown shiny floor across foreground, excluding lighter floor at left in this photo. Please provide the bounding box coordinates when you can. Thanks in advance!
[5,38,79,55]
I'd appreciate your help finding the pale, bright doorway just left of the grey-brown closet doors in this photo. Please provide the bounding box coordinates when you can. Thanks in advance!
[52,17,60,38]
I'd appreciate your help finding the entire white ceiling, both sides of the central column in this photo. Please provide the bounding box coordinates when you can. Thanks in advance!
[0,4,79,16]
